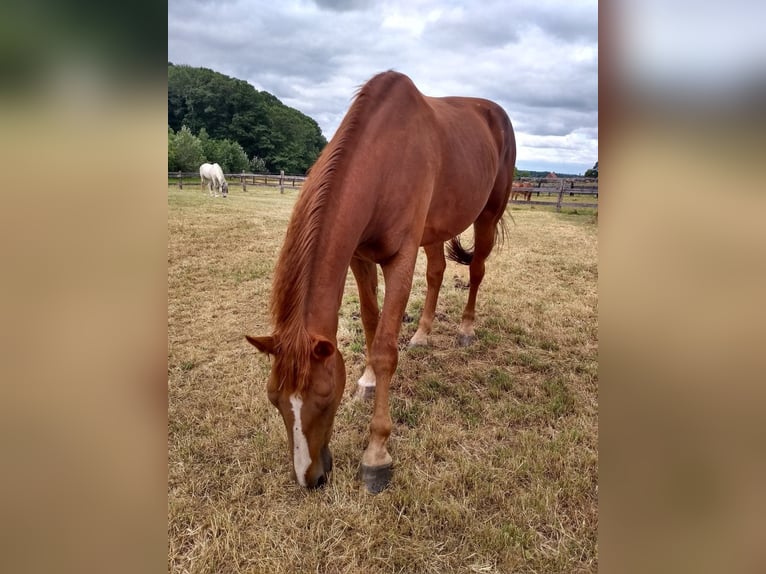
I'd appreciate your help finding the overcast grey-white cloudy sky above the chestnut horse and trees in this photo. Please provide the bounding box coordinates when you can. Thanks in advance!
[168,0,598,174]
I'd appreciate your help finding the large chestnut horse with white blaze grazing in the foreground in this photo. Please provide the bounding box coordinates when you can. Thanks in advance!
[246,71,516,492]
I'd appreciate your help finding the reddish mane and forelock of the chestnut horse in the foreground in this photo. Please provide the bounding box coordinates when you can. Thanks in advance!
[270,72,404,391]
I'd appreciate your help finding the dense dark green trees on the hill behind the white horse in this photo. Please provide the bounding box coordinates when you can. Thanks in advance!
[168,62,327,174]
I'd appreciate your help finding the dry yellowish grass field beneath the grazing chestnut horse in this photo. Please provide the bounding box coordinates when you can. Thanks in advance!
[168,186,598,574]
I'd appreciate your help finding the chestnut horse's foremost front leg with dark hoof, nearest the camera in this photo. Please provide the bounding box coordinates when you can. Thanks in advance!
[360,244,418,493]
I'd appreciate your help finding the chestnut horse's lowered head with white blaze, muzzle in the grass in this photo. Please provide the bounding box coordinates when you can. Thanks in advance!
[246,335,346,488]
